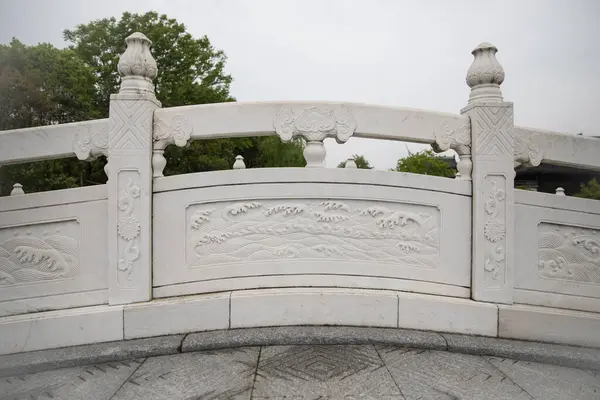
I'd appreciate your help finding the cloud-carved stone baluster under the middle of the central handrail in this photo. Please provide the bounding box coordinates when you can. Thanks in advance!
[273,106,356,168]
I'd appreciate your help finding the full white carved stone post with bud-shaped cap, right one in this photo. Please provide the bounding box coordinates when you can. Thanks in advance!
[461,43,515,304]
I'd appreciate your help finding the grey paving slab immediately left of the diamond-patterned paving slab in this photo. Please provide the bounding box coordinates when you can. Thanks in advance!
[113,348,259,400]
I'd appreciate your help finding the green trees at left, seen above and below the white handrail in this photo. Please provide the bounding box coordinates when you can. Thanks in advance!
[0,12,304,195]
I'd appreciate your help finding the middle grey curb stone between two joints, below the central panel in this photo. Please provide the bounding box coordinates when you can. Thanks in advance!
[182,326,446,352]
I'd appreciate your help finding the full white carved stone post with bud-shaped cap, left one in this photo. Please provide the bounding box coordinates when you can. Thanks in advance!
[108,33,160,304]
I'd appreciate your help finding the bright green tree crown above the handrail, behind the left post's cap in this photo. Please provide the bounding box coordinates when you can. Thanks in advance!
[64,11,234,111]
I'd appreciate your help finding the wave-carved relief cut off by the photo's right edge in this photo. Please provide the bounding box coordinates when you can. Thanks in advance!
[538,222,600,285]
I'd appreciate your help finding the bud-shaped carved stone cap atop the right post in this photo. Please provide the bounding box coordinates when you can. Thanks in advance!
[467,43,504,104]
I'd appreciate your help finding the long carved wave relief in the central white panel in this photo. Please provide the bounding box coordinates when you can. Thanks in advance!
[186,199,440,268]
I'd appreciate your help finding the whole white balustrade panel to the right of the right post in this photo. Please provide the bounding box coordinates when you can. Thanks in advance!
[515,197,600,300]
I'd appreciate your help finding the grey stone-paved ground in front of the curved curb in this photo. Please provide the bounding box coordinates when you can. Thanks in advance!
[0,345,600,400]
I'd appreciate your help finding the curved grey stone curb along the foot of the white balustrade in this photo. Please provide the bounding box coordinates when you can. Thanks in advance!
[0,326,600,377]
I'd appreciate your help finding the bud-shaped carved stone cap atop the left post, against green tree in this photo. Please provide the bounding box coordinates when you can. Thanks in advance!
[117,32,158,93]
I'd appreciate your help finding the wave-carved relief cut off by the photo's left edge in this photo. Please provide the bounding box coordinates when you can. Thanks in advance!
[0,219,81,287]
